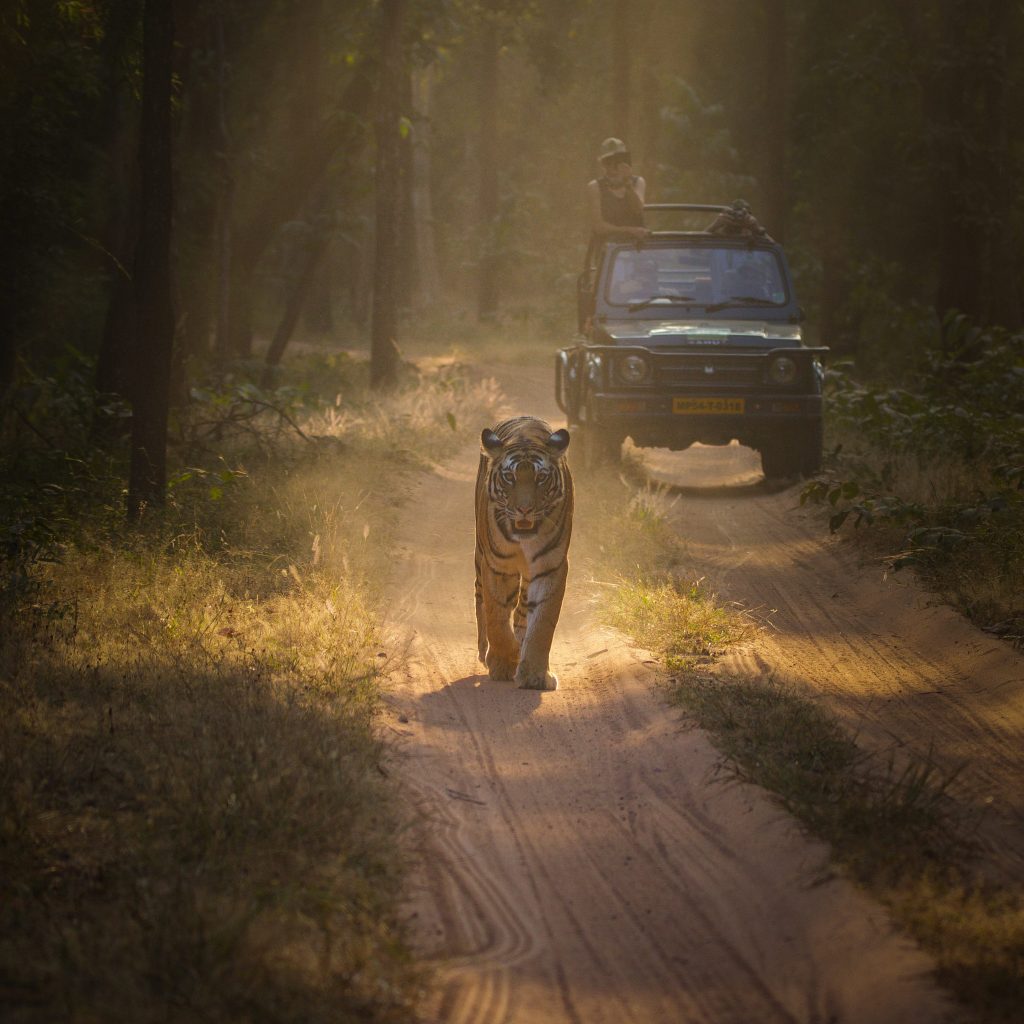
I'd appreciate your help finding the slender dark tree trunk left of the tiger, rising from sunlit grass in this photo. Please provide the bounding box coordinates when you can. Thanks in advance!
[370,0,406,387]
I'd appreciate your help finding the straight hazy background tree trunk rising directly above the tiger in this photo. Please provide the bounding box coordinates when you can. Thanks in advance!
[476,20,500,321]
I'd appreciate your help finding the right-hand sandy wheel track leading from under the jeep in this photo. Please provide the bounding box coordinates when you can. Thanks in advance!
[642,446,1024,881]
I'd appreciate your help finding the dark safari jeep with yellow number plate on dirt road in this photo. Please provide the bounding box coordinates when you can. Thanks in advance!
[555,204,827,478]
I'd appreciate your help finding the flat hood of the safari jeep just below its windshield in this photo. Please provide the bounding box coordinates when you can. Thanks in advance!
[594,319,802,348]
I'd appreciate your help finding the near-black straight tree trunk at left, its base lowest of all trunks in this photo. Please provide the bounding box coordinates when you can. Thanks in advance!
[128,0,174,520]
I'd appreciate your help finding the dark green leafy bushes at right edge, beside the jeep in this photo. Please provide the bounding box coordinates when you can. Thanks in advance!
[801,316,1024,639]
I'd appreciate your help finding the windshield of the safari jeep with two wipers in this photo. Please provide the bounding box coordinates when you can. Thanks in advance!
[604,245,787,312]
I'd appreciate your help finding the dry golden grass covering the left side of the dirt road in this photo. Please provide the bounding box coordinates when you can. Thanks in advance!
[0,358,503,1022]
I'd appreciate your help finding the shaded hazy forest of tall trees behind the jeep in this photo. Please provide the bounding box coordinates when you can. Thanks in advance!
[0,0,1024,500]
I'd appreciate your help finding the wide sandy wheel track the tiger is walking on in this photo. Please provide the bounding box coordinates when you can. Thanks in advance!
[387,372,945,1024]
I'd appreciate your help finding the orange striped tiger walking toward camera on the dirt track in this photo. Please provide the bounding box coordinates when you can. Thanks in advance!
[476,416,572,690]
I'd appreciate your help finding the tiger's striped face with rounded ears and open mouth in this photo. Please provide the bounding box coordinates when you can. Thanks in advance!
[481,430,569,540]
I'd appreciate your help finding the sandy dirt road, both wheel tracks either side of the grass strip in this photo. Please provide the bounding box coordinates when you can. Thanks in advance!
[376,370,1024,1024]
